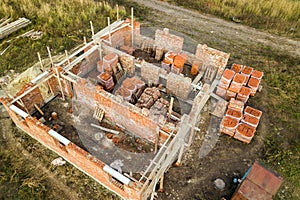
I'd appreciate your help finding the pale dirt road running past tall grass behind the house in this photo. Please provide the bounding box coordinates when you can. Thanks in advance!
[132,0,300,57]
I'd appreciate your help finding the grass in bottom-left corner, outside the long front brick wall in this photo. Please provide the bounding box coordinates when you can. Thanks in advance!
[0,124,119,200]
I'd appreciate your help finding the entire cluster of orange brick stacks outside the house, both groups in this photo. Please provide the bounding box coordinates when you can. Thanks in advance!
[216,64,263,144]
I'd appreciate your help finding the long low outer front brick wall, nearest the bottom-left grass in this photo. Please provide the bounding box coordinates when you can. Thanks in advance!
[0,98,141,200]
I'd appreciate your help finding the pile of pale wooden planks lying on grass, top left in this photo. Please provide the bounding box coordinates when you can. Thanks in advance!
[0,17,31,39]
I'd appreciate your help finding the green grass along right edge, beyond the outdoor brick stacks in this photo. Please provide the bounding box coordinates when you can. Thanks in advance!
[233,48,300,200]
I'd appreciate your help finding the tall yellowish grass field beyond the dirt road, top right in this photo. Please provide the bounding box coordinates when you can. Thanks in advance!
[162,0,300,39]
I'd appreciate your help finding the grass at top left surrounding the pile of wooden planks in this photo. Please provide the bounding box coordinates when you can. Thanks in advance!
[0,0,126,76]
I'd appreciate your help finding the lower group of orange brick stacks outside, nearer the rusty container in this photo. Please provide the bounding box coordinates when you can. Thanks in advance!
[220,98,262,144]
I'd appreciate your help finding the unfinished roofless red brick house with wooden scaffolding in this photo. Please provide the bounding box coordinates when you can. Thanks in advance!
[0,13,229,199]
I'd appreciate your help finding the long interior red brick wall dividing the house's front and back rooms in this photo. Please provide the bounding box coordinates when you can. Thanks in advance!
[74,80,159,143]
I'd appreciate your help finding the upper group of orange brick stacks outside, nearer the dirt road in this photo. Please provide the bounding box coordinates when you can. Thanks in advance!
[216,64,263,103]
